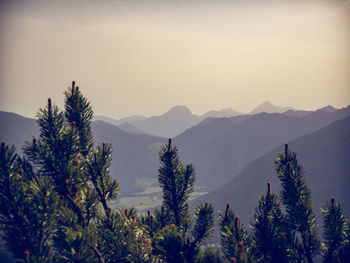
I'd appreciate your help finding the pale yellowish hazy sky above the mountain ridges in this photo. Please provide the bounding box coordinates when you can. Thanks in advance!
[0,0,350,118]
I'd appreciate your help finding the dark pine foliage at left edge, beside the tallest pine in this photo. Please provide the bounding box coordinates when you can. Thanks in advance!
[0,143,57,262]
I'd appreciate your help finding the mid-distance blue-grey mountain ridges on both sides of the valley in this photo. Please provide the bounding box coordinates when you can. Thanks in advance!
[0,103,350,200]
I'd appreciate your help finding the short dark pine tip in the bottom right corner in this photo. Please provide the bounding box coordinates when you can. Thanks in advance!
[321,198,350,263]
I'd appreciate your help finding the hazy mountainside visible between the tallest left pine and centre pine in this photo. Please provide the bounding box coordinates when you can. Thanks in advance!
[92,121,166,195]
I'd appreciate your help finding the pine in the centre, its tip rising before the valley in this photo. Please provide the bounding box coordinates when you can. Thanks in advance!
[154,139,214,262]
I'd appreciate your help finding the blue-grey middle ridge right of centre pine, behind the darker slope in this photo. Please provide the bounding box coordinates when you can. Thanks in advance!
[174,107,350,189]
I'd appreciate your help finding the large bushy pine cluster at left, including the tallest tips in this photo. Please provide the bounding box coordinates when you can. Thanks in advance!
[0,82,151,263]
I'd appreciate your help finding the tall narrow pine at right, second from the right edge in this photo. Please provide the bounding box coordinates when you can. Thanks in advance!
[275,143,320,263]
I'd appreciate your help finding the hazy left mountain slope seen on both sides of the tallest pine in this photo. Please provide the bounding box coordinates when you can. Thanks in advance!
[0,111,166,195]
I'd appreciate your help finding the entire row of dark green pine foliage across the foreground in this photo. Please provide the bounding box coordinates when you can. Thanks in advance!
[0,85,350,263]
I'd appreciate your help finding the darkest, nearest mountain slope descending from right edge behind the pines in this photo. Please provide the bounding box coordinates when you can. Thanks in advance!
[194,117,350,229]
